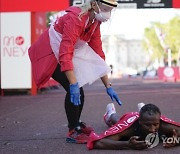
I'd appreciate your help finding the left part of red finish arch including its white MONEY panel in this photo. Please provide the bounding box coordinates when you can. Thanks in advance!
[0,0,69,94]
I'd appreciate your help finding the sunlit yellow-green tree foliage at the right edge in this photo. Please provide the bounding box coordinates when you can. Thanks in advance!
[143,16,180,63]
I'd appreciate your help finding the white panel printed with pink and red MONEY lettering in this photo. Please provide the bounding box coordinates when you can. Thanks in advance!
[1,12,31,89]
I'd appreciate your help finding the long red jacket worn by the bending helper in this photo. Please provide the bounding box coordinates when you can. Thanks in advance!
[28,7,105,87]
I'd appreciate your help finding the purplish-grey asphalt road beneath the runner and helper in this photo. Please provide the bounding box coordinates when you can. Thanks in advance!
[0,79,180,154]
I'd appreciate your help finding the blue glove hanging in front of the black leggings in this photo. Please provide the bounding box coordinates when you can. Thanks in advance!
[70,83,81,106]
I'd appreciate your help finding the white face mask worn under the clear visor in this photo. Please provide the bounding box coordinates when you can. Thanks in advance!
[94,4,111,22]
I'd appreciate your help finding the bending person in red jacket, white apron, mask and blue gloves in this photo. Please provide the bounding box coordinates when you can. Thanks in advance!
[28,0,121,143]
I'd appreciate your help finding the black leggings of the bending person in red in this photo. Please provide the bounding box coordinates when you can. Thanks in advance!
[52,64,84,130]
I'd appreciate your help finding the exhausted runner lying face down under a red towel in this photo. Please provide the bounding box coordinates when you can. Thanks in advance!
[87,103,180,150]
